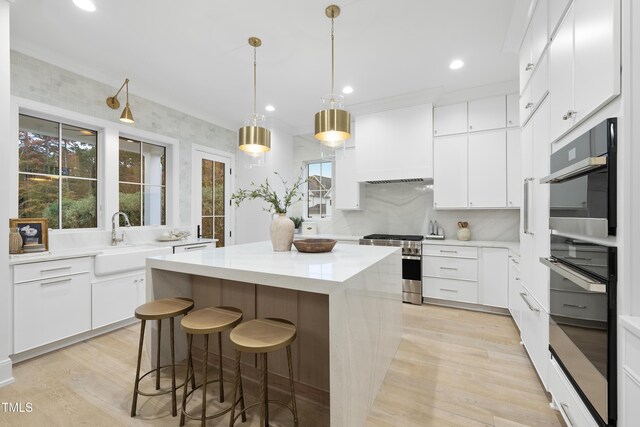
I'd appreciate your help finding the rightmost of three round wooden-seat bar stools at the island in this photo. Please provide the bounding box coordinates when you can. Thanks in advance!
[229,318,298,427]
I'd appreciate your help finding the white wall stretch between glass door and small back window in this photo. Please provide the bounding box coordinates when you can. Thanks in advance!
[235,127,297,244]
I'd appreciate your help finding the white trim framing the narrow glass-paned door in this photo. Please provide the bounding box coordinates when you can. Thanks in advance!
[190,144,237,246]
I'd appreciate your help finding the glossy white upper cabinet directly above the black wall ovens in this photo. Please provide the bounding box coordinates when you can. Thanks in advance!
[549,0,620,141]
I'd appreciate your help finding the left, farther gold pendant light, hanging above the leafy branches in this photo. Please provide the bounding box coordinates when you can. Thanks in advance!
[238,37,271,156]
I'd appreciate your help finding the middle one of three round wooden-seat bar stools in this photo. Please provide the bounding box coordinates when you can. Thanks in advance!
[180,307,246,426]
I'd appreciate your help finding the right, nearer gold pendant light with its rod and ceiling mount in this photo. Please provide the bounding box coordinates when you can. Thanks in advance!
[315,5,351,147]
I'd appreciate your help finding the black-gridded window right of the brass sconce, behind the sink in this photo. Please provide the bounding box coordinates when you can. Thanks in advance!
[119,138,166,225]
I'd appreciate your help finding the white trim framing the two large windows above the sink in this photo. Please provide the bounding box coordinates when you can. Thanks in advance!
[9,96,180,233]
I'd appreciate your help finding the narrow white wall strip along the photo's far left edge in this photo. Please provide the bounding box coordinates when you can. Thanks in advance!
[0,0,13,387]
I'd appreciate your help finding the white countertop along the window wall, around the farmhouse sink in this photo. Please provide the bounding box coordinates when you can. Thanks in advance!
[9,238,215,265]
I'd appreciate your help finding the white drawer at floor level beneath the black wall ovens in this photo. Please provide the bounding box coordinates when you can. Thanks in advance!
[549,359,597,427]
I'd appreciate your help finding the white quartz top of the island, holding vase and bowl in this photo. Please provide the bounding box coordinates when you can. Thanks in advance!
[147,241,401,293]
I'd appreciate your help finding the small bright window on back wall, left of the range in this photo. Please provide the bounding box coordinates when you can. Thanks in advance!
[306,162,333,218]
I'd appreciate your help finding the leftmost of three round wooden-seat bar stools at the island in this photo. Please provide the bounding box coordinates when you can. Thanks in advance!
[131,298,195,417]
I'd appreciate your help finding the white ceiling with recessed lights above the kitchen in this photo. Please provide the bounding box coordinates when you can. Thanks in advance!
[11,0,528,133]
